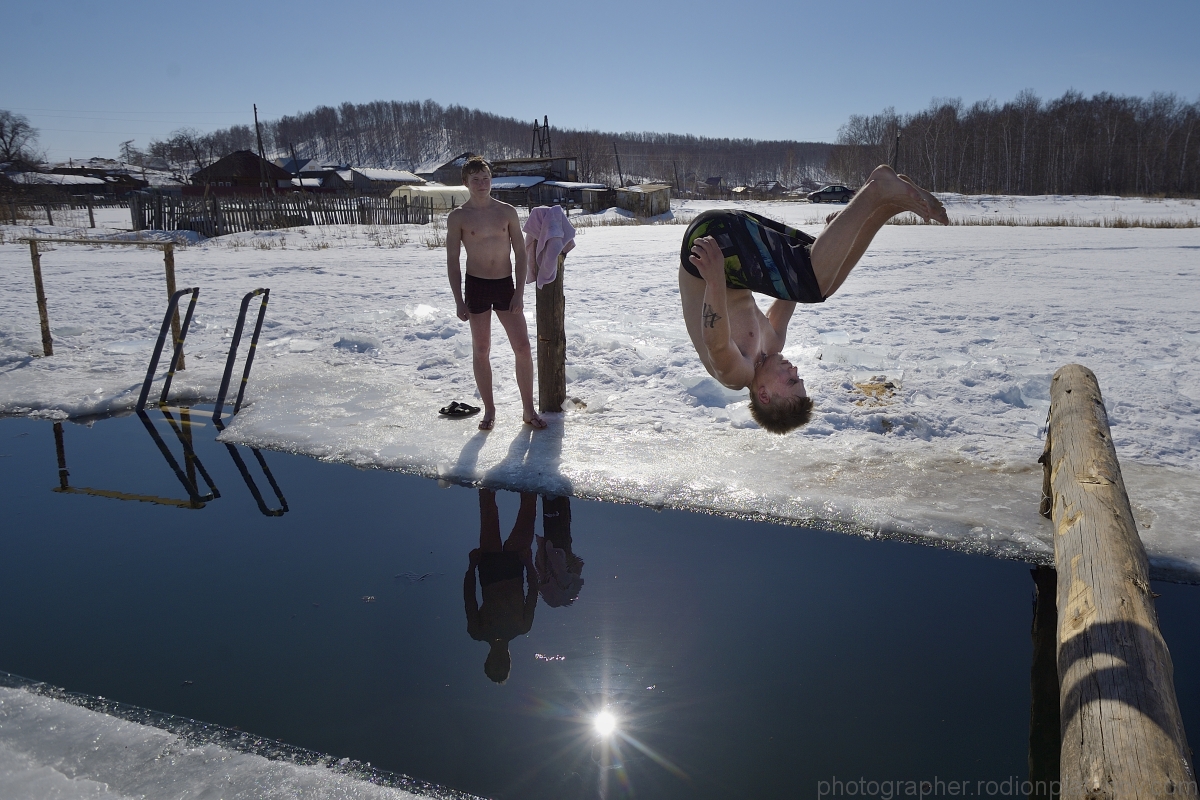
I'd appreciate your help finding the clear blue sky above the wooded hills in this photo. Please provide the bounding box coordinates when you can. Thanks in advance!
[0,0,1200,160]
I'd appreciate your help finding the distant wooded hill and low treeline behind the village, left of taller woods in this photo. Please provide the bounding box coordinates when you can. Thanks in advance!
[148,100,832,186]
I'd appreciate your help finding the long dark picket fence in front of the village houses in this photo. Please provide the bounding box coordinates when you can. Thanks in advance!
[130,193,433,236]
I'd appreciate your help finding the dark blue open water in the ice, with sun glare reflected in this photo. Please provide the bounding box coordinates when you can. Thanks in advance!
[0,413,1200,798]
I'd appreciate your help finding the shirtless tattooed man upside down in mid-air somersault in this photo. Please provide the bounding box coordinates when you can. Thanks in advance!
[679,166,949,433]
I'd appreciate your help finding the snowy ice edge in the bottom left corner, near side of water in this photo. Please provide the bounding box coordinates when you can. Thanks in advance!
[0,676,477,800]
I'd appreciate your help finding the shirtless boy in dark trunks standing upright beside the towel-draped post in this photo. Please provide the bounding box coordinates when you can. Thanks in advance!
[446,156,546,431]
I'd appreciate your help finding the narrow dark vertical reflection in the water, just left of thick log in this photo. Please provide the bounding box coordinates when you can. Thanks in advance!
[1028,566,1062,800]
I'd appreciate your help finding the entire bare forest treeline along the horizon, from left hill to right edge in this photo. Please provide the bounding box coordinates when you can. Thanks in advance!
[152,90,1200,196]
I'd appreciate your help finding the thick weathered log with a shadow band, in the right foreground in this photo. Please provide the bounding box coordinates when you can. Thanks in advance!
[1048,365,1198,800]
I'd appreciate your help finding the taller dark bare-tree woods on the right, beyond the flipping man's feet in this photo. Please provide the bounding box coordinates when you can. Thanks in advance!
[828,90,1200,196]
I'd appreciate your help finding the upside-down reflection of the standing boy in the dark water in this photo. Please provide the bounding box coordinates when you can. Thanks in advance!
[462,489,538,684]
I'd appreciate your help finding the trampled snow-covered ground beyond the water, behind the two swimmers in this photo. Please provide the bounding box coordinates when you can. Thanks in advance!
[7,196,1200,581]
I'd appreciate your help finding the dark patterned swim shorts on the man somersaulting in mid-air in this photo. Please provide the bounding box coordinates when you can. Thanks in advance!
[679,210,824,302]
